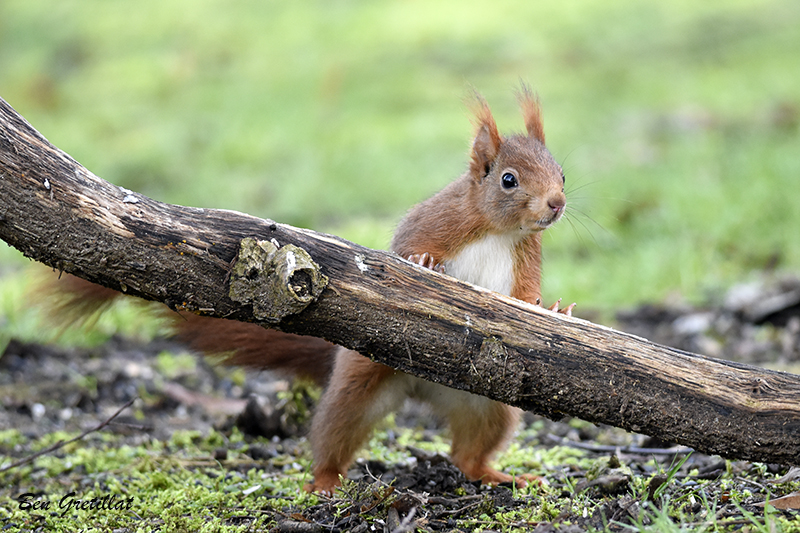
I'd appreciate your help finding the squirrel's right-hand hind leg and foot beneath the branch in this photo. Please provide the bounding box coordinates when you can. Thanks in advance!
[447,397,539,487]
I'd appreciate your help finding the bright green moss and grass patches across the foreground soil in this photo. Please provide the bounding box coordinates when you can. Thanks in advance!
[0,428,800,533]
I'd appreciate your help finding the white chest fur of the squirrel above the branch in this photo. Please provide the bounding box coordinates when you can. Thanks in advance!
[444,235,518,295]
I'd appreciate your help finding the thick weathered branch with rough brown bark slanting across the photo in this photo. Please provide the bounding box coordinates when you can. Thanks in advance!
[0,99,800,464]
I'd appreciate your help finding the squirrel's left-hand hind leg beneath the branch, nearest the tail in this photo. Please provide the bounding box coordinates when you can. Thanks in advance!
[305,348,406,494]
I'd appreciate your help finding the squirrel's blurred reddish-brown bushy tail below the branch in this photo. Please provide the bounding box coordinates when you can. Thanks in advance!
[43,275,336,386]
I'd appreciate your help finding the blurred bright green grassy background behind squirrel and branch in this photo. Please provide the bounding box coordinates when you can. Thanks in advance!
[0,0,800,336]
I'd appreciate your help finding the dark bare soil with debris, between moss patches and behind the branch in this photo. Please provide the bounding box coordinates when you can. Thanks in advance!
[0,278,800,532]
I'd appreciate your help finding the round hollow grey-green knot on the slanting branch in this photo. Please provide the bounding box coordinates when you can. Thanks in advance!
[228,237,328,324]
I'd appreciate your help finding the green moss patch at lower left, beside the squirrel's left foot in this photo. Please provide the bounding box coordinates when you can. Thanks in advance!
[0,431,317,532]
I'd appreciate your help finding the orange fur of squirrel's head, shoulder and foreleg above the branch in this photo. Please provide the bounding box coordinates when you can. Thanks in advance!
[391,85,566,278]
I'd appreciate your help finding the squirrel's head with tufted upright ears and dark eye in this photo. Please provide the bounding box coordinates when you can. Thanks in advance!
[469,85,567,234]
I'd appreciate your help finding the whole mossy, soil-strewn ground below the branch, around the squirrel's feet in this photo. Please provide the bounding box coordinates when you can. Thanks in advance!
[0,306,800,533]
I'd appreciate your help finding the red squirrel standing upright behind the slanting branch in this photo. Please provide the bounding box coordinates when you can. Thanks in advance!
[53,86,574,493]
